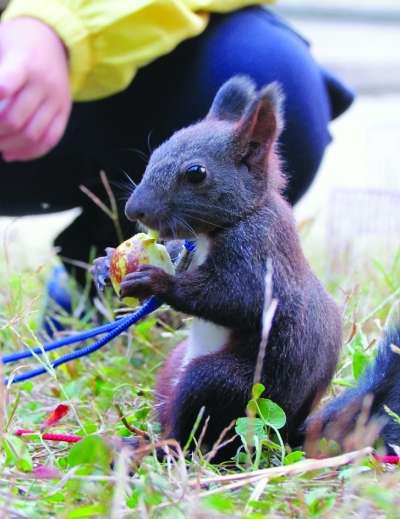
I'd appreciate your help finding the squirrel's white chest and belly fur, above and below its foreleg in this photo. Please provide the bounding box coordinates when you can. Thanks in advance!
[184,236,230,366]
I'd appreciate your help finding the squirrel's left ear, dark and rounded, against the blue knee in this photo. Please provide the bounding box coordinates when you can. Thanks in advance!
[207,76,255,122]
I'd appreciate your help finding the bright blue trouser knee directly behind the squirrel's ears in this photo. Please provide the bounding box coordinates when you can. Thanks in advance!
[191,7,331,202]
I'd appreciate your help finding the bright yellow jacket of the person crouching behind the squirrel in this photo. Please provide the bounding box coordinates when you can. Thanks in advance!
[3,0,267,101]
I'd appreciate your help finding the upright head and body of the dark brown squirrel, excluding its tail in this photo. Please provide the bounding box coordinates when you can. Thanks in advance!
[92,76,398,462]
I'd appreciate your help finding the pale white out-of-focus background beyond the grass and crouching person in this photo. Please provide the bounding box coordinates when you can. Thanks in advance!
[0,0,400,274]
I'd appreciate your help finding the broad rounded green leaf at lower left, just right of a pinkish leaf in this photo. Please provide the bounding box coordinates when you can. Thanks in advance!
[68,435,112,469]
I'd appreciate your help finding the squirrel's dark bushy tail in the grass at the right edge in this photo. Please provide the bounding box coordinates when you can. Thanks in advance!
[305,326,400,453]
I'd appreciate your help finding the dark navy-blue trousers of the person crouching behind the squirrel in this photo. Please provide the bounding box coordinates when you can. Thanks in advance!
[0,7,352,272]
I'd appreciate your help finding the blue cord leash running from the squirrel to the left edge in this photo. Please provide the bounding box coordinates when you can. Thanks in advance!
[1,241,195,385]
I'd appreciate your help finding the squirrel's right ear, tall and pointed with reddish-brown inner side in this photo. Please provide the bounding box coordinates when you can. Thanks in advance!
[236,82,284,166]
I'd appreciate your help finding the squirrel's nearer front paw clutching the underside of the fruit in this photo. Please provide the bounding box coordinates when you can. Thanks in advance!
[120,265,173,299]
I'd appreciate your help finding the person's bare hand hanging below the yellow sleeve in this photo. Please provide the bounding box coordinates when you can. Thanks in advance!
[0,18,71,161]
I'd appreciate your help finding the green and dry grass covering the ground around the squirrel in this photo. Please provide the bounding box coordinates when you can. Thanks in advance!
[0,237,400,519]
